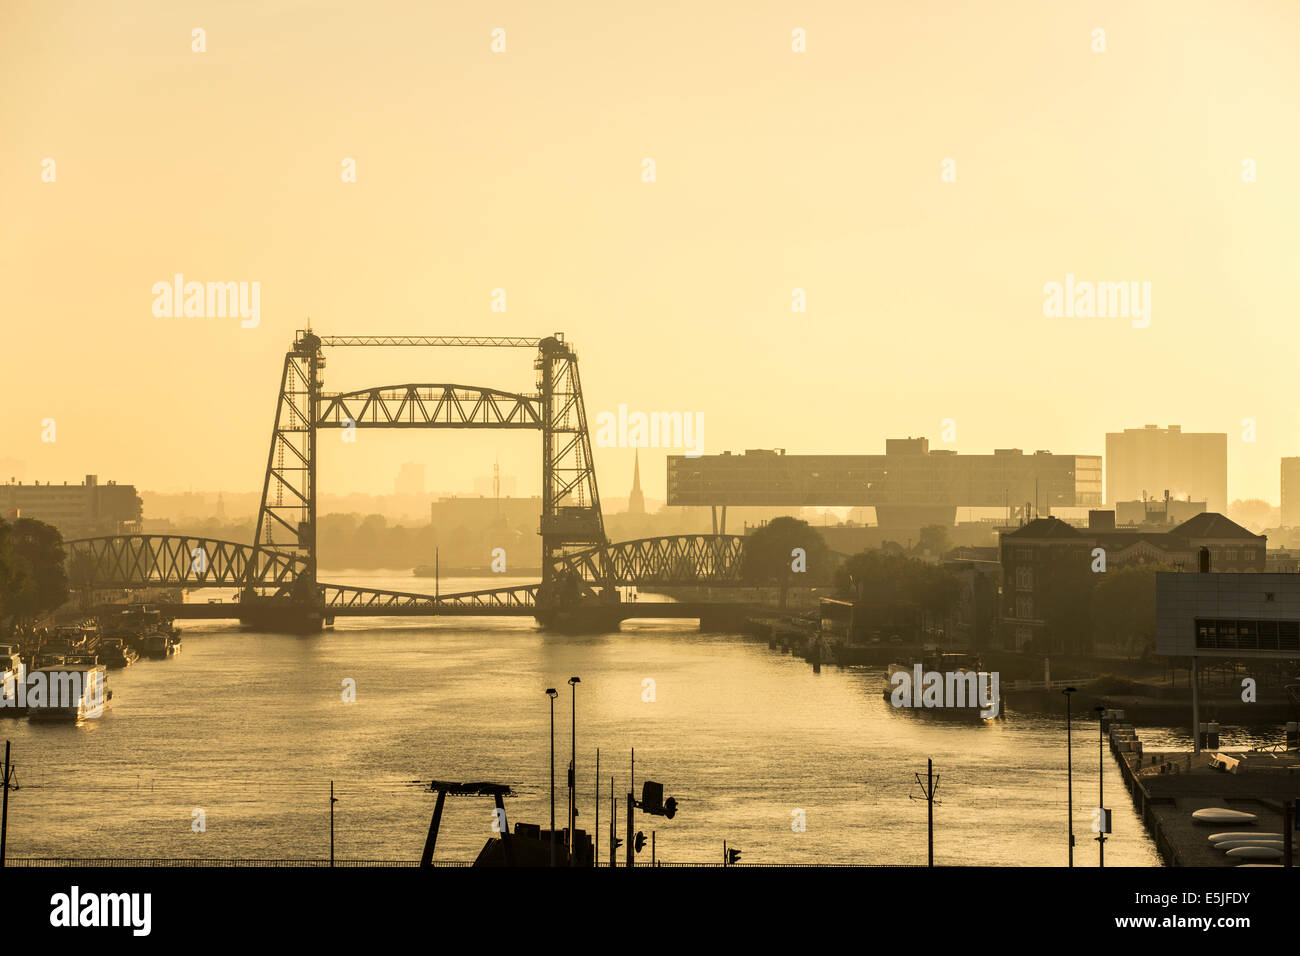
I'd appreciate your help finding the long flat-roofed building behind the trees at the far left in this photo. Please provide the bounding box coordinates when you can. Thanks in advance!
[0,475,143,541]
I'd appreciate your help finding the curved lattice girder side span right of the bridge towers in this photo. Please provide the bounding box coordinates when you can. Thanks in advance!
[555,535,745,587]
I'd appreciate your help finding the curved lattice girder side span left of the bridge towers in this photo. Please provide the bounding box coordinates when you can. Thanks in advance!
[64,535,306,588]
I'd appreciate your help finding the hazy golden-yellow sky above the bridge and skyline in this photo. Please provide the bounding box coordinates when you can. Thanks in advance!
[0,0,1300,501]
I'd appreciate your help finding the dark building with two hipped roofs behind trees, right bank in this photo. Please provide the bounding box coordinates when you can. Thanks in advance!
[1000,511,1268,649]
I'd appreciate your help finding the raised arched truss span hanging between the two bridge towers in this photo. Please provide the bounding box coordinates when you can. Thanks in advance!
[316,384,542,429]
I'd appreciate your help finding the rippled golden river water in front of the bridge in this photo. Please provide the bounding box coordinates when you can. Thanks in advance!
[0,575,1279,866]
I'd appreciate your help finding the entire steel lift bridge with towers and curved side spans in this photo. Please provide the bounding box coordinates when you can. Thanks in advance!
[66,330,746,632]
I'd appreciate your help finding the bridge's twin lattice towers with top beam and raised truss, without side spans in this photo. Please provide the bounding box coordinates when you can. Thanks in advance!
[243,330,618,627]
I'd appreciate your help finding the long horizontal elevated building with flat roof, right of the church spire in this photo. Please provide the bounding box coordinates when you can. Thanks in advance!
[668,438,1101,529]
